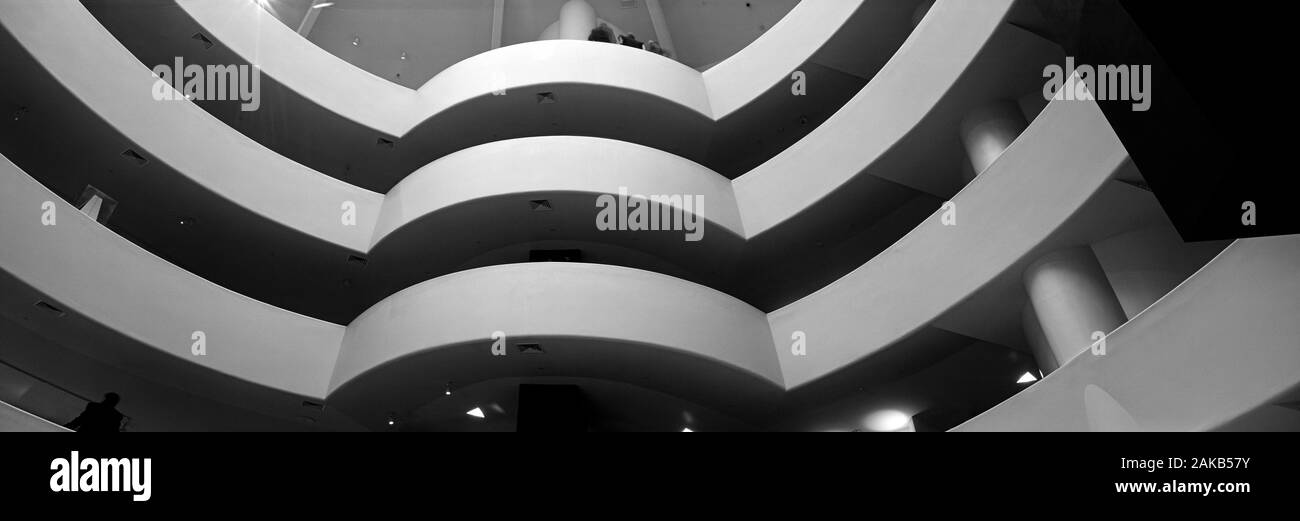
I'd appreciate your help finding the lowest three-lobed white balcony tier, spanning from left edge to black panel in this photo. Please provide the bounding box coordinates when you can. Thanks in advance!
[0,91,1196,422]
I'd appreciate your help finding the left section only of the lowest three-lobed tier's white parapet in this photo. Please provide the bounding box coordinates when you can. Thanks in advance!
[0,154,343,398]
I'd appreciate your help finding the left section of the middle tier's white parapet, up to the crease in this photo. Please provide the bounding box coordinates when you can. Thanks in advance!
[0,0,384,251]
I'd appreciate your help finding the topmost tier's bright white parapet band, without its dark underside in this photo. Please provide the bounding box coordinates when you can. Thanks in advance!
[178,0,865,136]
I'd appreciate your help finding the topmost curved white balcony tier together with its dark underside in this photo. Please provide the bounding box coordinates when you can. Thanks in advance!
[87,0,920,183]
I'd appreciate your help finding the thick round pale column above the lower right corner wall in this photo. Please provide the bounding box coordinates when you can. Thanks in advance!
[1024,246,1126,365]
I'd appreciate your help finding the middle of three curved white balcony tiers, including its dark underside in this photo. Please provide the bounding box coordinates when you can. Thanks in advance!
[4,1,1054,322]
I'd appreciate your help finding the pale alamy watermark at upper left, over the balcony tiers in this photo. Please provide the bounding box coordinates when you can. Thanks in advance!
[152,56,261,112]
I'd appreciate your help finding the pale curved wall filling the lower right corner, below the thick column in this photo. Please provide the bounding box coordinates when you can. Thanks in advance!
[954,235,1300,431]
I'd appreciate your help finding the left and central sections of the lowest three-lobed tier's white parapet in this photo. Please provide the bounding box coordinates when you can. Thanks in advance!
[0,160,781,407]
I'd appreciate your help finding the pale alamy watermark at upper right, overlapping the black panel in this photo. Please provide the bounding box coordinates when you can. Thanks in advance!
[1043,56,1152,112]
